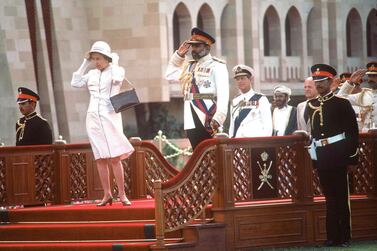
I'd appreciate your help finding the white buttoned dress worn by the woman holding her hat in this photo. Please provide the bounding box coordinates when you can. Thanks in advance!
[71,64,134,159]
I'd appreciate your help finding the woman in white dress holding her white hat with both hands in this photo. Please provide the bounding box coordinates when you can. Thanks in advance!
[71,41,134,206]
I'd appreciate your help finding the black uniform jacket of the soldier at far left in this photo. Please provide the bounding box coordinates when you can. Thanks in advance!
[16,112,52,146]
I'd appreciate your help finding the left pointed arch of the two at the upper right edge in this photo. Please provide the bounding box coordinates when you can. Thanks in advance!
[346,8,363,57]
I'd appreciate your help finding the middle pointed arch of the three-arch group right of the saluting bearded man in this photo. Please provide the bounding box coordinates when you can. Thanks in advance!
[285,6,302,56]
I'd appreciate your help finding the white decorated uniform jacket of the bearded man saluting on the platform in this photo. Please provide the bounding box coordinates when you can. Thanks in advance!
[166,52,229,130]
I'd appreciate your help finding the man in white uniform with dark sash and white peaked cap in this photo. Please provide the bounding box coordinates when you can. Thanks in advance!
[229,64,272,138]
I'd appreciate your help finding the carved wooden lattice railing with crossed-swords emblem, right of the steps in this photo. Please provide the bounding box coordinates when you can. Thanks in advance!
[155,132,377,247]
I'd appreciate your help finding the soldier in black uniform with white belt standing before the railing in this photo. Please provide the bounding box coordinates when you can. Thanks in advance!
[304,64,359,247]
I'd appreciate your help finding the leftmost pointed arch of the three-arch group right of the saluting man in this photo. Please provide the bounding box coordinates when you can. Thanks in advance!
[263,6,281,56]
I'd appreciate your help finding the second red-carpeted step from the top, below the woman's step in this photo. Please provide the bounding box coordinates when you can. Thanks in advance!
[0,221,182,241]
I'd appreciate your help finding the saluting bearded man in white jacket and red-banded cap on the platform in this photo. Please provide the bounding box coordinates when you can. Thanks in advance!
[166,28,229,149]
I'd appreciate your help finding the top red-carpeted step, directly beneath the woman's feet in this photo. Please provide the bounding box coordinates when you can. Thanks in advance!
[0,200,155,223]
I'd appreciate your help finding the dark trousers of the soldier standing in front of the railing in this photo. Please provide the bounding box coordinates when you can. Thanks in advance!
[318,167,351,243]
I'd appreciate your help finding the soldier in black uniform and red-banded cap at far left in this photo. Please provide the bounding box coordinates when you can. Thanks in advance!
[16,87,52,146]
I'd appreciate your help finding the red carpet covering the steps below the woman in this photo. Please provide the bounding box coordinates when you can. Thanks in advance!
[0,200,182,251]
